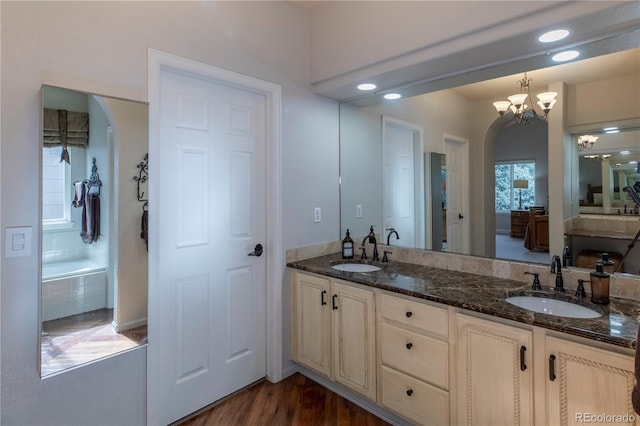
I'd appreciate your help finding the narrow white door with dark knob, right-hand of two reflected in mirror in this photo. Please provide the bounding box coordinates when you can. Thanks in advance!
[444,136,469,253]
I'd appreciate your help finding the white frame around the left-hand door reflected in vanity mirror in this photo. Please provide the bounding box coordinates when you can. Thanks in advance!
[380,115,426,249]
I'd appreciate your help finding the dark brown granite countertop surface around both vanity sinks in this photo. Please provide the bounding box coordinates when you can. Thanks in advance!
[287,254,640,349]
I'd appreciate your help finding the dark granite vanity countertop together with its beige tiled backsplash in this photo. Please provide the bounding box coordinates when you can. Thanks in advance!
[287,251,640,348]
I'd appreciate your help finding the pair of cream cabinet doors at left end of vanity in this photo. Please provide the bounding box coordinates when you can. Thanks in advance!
[291,272,376,401]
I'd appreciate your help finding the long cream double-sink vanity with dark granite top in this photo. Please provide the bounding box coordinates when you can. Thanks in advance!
[288,255,640,425]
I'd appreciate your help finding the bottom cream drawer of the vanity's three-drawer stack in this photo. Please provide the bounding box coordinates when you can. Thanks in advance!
[382,365,449,425]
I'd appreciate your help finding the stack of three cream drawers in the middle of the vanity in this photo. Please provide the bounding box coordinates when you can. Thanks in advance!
[378,293,450,425]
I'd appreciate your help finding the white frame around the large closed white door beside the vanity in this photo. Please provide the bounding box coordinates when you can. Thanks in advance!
[147,49,284,424]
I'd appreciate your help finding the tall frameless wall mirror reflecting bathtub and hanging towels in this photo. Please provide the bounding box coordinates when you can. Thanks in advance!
[40,86,148,377]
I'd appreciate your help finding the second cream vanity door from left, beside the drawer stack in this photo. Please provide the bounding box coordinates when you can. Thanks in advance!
[331,282,376,401]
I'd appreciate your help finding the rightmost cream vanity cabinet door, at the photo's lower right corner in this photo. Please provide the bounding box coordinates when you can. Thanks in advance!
[545,337,638,425]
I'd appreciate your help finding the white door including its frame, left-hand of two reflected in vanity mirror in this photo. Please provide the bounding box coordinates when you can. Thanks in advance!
[377,117,423,247]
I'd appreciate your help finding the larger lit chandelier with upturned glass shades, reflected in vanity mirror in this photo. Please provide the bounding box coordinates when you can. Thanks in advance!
[493,72,558,124]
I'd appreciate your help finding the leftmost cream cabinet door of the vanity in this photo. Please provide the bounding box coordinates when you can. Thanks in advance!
[291,273,331,376]
